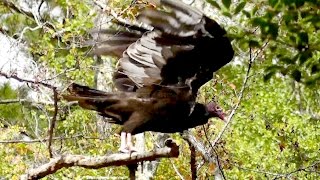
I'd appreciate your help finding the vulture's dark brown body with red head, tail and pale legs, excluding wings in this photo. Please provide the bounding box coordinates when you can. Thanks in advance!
[63,83,224,152]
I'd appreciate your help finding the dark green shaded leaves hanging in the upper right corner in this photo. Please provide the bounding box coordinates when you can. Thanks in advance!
[209,0,320,86]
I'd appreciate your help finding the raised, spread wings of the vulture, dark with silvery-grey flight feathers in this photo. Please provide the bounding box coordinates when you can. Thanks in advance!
[89,0,234,94]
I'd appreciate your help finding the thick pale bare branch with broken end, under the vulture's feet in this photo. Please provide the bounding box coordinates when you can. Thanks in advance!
[21,141,179,179]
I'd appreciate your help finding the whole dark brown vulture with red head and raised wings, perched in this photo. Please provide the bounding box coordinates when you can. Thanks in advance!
[64,0,234,151]
